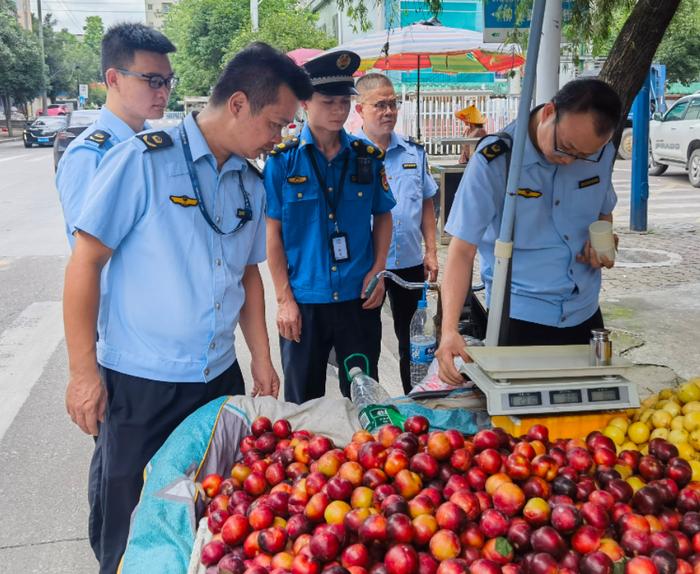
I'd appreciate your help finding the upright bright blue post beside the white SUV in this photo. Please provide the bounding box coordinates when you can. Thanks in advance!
[630,72,651,231]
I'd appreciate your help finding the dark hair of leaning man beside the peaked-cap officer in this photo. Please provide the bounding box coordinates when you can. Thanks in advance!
[209,42,313,114]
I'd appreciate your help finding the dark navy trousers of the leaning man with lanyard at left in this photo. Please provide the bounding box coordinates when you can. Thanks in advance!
[88,362,245,574]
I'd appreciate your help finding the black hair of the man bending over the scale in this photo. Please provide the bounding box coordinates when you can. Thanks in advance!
[552,78,622,136]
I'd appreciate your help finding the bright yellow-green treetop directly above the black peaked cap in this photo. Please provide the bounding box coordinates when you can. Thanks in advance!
[222,0,335,58]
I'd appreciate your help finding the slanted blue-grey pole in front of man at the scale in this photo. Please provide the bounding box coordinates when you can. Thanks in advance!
[486,0,558,346]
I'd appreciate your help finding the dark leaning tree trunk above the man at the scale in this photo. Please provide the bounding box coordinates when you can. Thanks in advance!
[599,0,681,146]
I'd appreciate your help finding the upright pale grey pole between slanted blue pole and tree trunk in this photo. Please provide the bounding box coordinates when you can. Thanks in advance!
[535,1,562,104]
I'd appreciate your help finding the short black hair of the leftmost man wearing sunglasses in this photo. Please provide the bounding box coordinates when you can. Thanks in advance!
[102,22,176,78]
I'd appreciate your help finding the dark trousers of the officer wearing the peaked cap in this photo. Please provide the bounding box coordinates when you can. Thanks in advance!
[280,299,382,404]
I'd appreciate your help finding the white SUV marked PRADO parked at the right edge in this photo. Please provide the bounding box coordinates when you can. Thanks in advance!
[649,93,700,187]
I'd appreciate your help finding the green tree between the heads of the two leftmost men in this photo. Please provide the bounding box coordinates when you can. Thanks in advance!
[165,0,249,96]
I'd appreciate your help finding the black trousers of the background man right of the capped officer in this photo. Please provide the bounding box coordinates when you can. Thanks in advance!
[384,265,425,394]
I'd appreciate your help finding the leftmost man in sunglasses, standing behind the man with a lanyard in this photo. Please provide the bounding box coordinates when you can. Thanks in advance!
[56,23,175,249]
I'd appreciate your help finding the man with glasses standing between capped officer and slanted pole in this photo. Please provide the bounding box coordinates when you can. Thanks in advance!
[355,74,438,394]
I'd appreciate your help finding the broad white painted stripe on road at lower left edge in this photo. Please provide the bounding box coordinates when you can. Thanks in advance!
[0,301,63,441]
